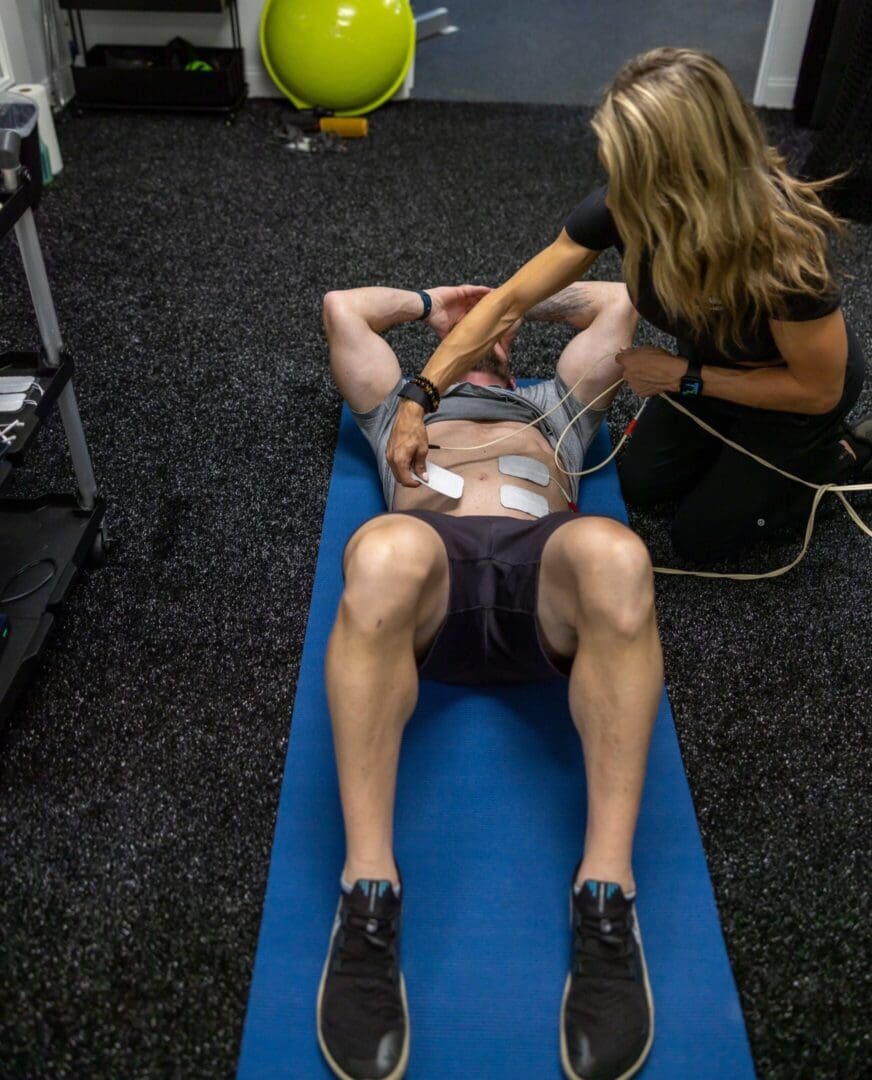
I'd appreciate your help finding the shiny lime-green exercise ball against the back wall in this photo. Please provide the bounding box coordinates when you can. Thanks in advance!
[260,0,415,117]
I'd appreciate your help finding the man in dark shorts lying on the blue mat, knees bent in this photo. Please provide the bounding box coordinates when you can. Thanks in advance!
[318,283,662,1080]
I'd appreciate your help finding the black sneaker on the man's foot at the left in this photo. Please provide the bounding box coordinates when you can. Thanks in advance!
[318,880,408,1080]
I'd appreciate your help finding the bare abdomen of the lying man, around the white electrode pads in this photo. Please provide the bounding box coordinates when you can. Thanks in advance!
[392,420,572,521]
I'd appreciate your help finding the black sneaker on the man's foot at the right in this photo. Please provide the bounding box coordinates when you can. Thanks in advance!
[560,881,654,1080]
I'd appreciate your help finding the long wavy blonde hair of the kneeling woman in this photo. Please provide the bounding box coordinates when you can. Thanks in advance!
[593,48,842,348]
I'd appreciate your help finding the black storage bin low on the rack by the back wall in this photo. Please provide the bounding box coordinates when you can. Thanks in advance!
[72,45,245,109]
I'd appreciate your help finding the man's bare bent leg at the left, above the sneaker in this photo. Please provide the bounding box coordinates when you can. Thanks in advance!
[326,514,448,887]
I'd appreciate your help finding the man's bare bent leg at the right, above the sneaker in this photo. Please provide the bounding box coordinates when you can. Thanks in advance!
[538,517,663,893]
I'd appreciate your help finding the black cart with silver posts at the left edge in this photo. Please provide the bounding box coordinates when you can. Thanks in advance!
[0,103,106,719]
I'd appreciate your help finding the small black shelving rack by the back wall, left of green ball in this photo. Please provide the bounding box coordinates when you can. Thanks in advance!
[61,0,247,123]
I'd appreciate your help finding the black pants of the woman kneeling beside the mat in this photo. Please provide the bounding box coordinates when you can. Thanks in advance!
[618,330,864,563]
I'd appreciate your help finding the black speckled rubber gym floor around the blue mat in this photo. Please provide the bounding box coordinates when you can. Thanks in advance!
[0,103,872,1080]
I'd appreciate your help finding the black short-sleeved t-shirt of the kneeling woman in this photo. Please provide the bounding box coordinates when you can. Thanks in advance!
[565,187,842,367]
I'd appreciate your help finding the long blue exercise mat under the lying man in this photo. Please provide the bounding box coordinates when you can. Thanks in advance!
[238,409,754,1080]
